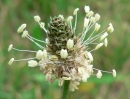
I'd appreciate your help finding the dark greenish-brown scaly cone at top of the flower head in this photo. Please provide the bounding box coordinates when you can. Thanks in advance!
[47,16,74,56]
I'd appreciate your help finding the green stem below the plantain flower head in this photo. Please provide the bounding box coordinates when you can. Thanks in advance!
[62,80,70,99]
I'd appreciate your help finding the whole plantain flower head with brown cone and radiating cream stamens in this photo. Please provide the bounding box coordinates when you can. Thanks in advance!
[8,6,116,91]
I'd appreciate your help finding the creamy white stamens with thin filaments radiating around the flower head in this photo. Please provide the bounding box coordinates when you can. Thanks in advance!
[8,6,116,91]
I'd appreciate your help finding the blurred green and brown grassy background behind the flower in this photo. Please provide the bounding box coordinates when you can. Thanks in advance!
[0,0,130,99]
